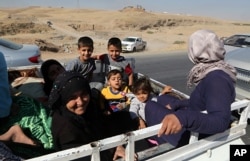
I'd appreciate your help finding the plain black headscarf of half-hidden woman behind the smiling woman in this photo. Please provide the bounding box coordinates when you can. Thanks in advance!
[41,59,64,96]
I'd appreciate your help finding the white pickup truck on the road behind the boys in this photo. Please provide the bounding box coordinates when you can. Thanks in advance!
[122,36,147,52]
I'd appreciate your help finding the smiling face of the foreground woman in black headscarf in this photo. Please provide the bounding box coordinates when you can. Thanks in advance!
[66,91,90,115]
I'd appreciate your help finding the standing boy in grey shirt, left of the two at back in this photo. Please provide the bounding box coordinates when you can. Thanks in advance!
[66,36,103,90]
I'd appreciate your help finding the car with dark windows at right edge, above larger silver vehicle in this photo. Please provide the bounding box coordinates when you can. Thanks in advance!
[222,34,250,52]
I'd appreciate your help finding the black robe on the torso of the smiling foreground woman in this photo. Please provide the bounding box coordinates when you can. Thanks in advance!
[52,103,104,150]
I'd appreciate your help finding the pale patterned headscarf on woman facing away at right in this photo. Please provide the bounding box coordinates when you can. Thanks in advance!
[187,30,236,87]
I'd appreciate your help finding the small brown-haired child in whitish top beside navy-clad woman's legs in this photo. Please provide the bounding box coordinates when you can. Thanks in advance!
[129,76,172,129]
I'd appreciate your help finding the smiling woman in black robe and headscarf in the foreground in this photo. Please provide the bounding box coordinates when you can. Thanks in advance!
[49,71,137,160]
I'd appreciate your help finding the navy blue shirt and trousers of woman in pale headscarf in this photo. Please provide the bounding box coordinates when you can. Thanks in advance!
[145,70,235,146]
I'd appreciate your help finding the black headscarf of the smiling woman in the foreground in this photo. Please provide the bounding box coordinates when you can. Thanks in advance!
[49,71,91,110]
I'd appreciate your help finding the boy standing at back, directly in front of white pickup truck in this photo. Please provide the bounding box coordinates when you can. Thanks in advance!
[100,37,133,87]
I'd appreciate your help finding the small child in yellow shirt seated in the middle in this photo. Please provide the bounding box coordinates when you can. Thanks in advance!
[101,69,130,114]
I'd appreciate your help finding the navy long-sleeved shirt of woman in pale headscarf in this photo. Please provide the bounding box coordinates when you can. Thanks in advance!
[175,70,235,134]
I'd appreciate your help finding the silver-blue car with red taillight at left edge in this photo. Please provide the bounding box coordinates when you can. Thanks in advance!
[0,38,42,68]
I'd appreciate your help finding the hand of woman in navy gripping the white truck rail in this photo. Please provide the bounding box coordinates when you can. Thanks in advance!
[158,114,182,137]
